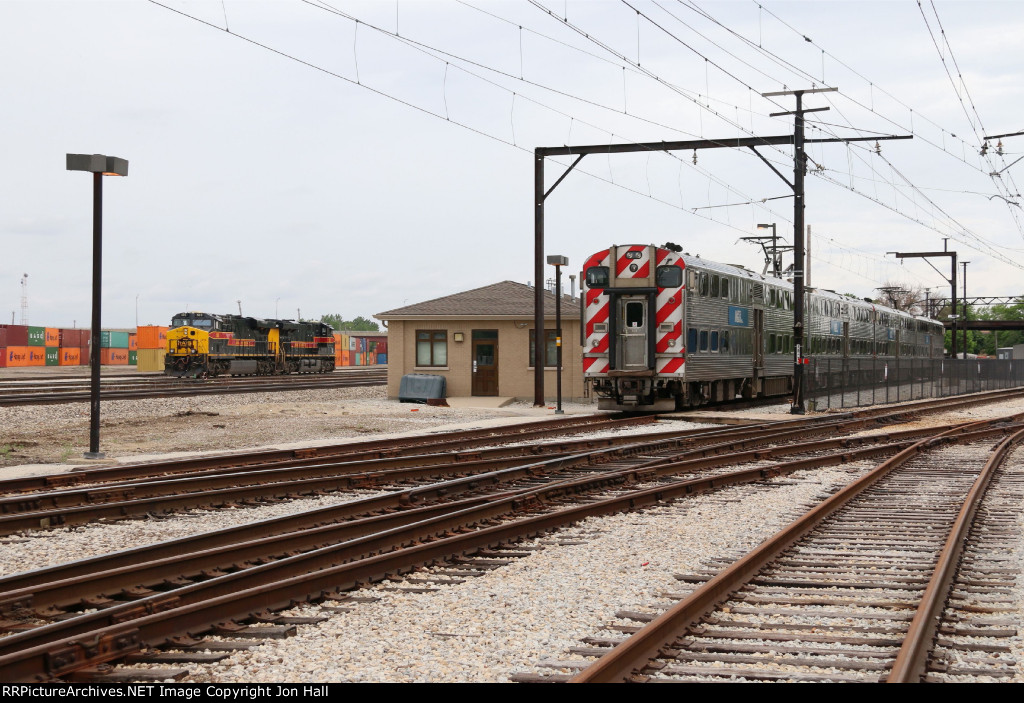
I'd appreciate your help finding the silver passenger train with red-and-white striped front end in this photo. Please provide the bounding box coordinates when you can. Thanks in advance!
[580,245,943,410]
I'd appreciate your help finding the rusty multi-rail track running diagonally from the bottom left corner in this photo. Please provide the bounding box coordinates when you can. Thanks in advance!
[0,390,1019,680]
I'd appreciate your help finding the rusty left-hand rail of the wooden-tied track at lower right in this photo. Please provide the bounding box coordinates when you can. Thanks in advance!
[569,414,1024,684]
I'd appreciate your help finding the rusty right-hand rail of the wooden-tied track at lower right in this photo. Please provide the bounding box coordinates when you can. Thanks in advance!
[886,423,1024,684]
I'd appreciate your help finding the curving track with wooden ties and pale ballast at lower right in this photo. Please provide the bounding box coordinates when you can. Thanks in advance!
[571,418,1024,683]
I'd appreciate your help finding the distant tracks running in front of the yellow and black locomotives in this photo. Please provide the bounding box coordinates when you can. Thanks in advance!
[0,367,387,406]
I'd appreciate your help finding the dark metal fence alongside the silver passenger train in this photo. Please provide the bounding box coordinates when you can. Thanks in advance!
[805,356,1024,410]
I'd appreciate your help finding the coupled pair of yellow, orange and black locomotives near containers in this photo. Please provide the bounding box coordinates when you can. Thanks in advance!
[164,312,335,377]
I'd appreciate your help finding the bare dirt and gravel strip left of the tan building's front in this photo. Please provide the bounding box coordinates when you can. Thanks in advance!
[0,386,591,467]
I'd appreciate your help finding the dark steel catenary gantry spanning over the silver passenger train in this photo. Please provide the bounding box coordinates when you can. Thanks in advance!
[534,88,913,413]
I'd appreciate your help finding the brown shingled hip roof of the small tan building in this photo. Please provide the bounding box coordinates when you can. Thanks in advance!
[374,280,580,319]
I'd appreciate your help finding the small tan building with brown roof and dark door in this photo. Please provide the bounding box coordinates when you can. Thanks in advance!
[374,280,583,401]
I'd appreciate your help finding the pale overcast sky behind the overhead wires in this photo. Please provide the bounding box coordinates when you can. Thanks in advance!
[0,0,1024,327]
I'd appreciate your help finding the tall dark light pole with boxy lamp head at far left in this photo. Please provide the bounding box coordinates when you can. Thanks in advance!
[67,153,128,458]
